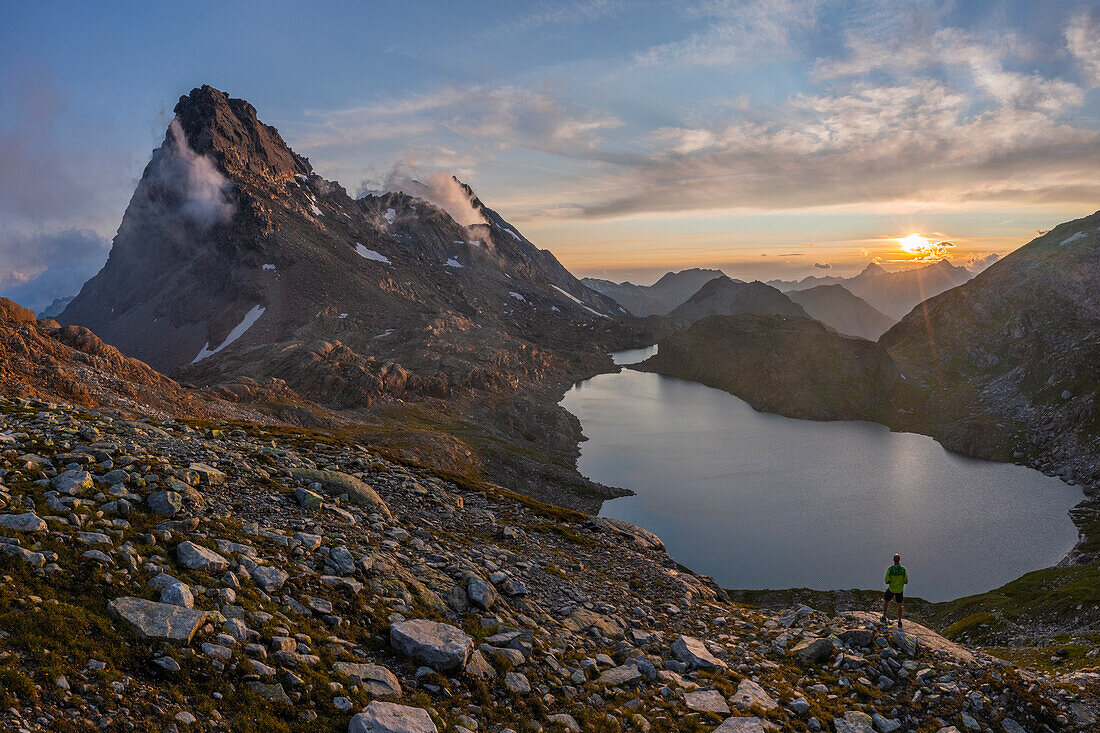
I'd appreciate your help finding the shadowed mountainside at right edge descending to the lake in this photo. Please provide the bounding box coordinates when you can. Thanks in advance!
[879,212,1100,484]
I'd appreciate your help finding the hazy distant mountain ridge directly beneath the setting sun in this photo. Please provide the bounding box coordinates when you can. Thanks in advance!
[768,260,972,320]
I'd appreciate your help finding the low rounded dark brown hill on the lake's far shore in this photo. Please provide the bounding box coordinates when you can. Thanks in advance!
[635,315,909,422]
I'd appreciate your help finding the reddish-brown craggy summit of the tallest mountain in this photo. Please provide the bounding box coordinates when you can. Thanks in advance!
[167,85,314,180]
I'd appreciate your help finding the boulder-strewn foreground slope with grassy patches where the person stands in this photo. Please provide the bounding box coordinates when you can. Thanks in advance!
[0,400,1100,733]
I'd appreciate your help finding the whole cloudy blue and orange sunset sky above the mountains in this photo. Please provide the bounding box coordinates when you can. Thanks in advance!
[0,0,1100,308]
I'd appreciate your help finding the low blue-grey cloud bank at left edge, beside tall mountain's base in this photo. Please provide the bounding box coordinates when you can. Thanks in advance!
[0,229,110,311]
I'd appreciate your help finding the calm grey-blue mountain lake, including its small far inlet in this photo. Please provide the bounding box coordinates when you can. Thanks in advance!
[562,347,1082,601]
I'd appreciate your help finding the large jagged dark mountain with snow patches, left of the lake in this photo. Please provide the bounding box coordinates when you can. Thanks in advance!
[58,87,624,406]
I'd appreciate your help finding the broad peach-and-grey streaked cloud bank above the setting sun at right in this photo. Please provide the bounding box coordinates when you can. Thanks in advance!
[553,72,1100,218]
